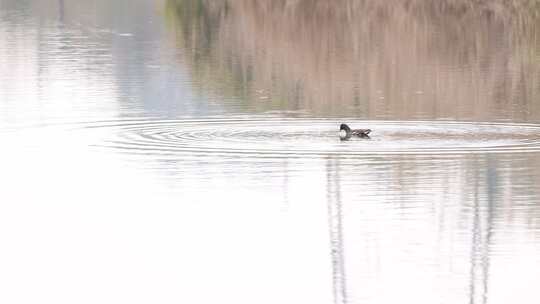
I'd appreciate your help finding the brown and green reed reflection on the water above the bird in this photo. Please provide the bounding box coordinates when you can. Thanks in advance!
[166,0,540,121]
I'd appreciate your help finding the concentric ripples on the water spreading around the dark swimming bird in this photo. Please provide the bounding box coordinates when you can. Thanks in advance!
[88,119,540,157]
